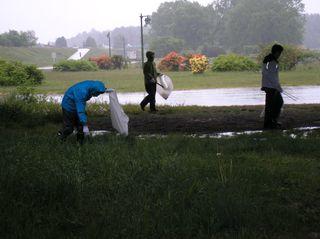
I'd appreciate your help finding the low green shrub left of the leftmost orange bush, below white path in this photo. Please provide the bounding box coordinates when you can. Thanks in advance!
[53,60,98,71]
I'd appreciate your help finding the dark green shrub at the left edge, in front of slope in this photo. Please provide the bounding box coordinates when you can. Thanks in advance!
[0,60,44,86]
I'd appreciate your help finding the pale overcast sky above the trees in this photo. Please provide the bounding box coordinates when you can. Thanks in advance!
[0,0,320,43]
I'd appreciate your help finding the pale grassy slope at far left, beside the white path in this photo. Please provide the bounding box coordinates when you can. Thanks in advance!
[0,46,76,66]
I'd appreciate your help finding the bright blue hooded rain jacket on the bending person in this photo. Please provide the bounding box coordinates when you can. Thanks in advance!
[61,80,106,125]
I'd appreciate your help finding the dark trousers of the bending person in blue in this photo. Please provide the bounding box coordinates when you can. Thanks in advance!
[59,108,84,143]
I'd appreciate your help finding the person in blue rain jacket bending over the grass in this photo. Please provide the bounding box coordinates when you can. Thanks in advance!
[58,80,106,143]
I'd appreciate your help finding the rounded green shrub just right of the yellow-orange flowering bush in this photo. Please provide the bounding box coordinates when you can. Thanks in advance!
[212,54,259,71]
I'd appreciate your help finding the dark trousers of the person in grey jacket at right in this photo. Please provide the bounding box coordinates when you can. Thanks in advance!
[264,88,283,127]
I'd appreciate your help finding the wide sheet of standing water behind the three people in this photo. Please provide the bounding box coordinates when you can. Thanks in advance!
[48,86,320,106]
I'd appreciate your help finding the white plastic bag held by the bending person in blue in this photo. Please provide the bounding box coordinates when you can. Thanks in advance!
[109,91,129,136]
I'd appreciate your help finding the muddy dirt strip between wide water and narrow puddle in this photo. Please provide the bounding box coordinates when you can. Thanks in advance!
[89,105,320,135]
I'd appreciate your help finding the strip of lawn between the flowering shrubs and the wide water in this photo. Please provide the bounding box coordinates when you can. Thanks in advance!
[0,68,320,94]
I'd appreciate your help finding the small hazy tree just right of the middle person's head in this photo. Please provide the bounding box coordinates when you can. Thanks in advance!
[150,37,184,57]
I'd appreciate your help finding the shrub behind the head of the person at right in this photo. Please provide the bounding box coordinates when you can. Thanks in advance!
[258,44,303,70]
